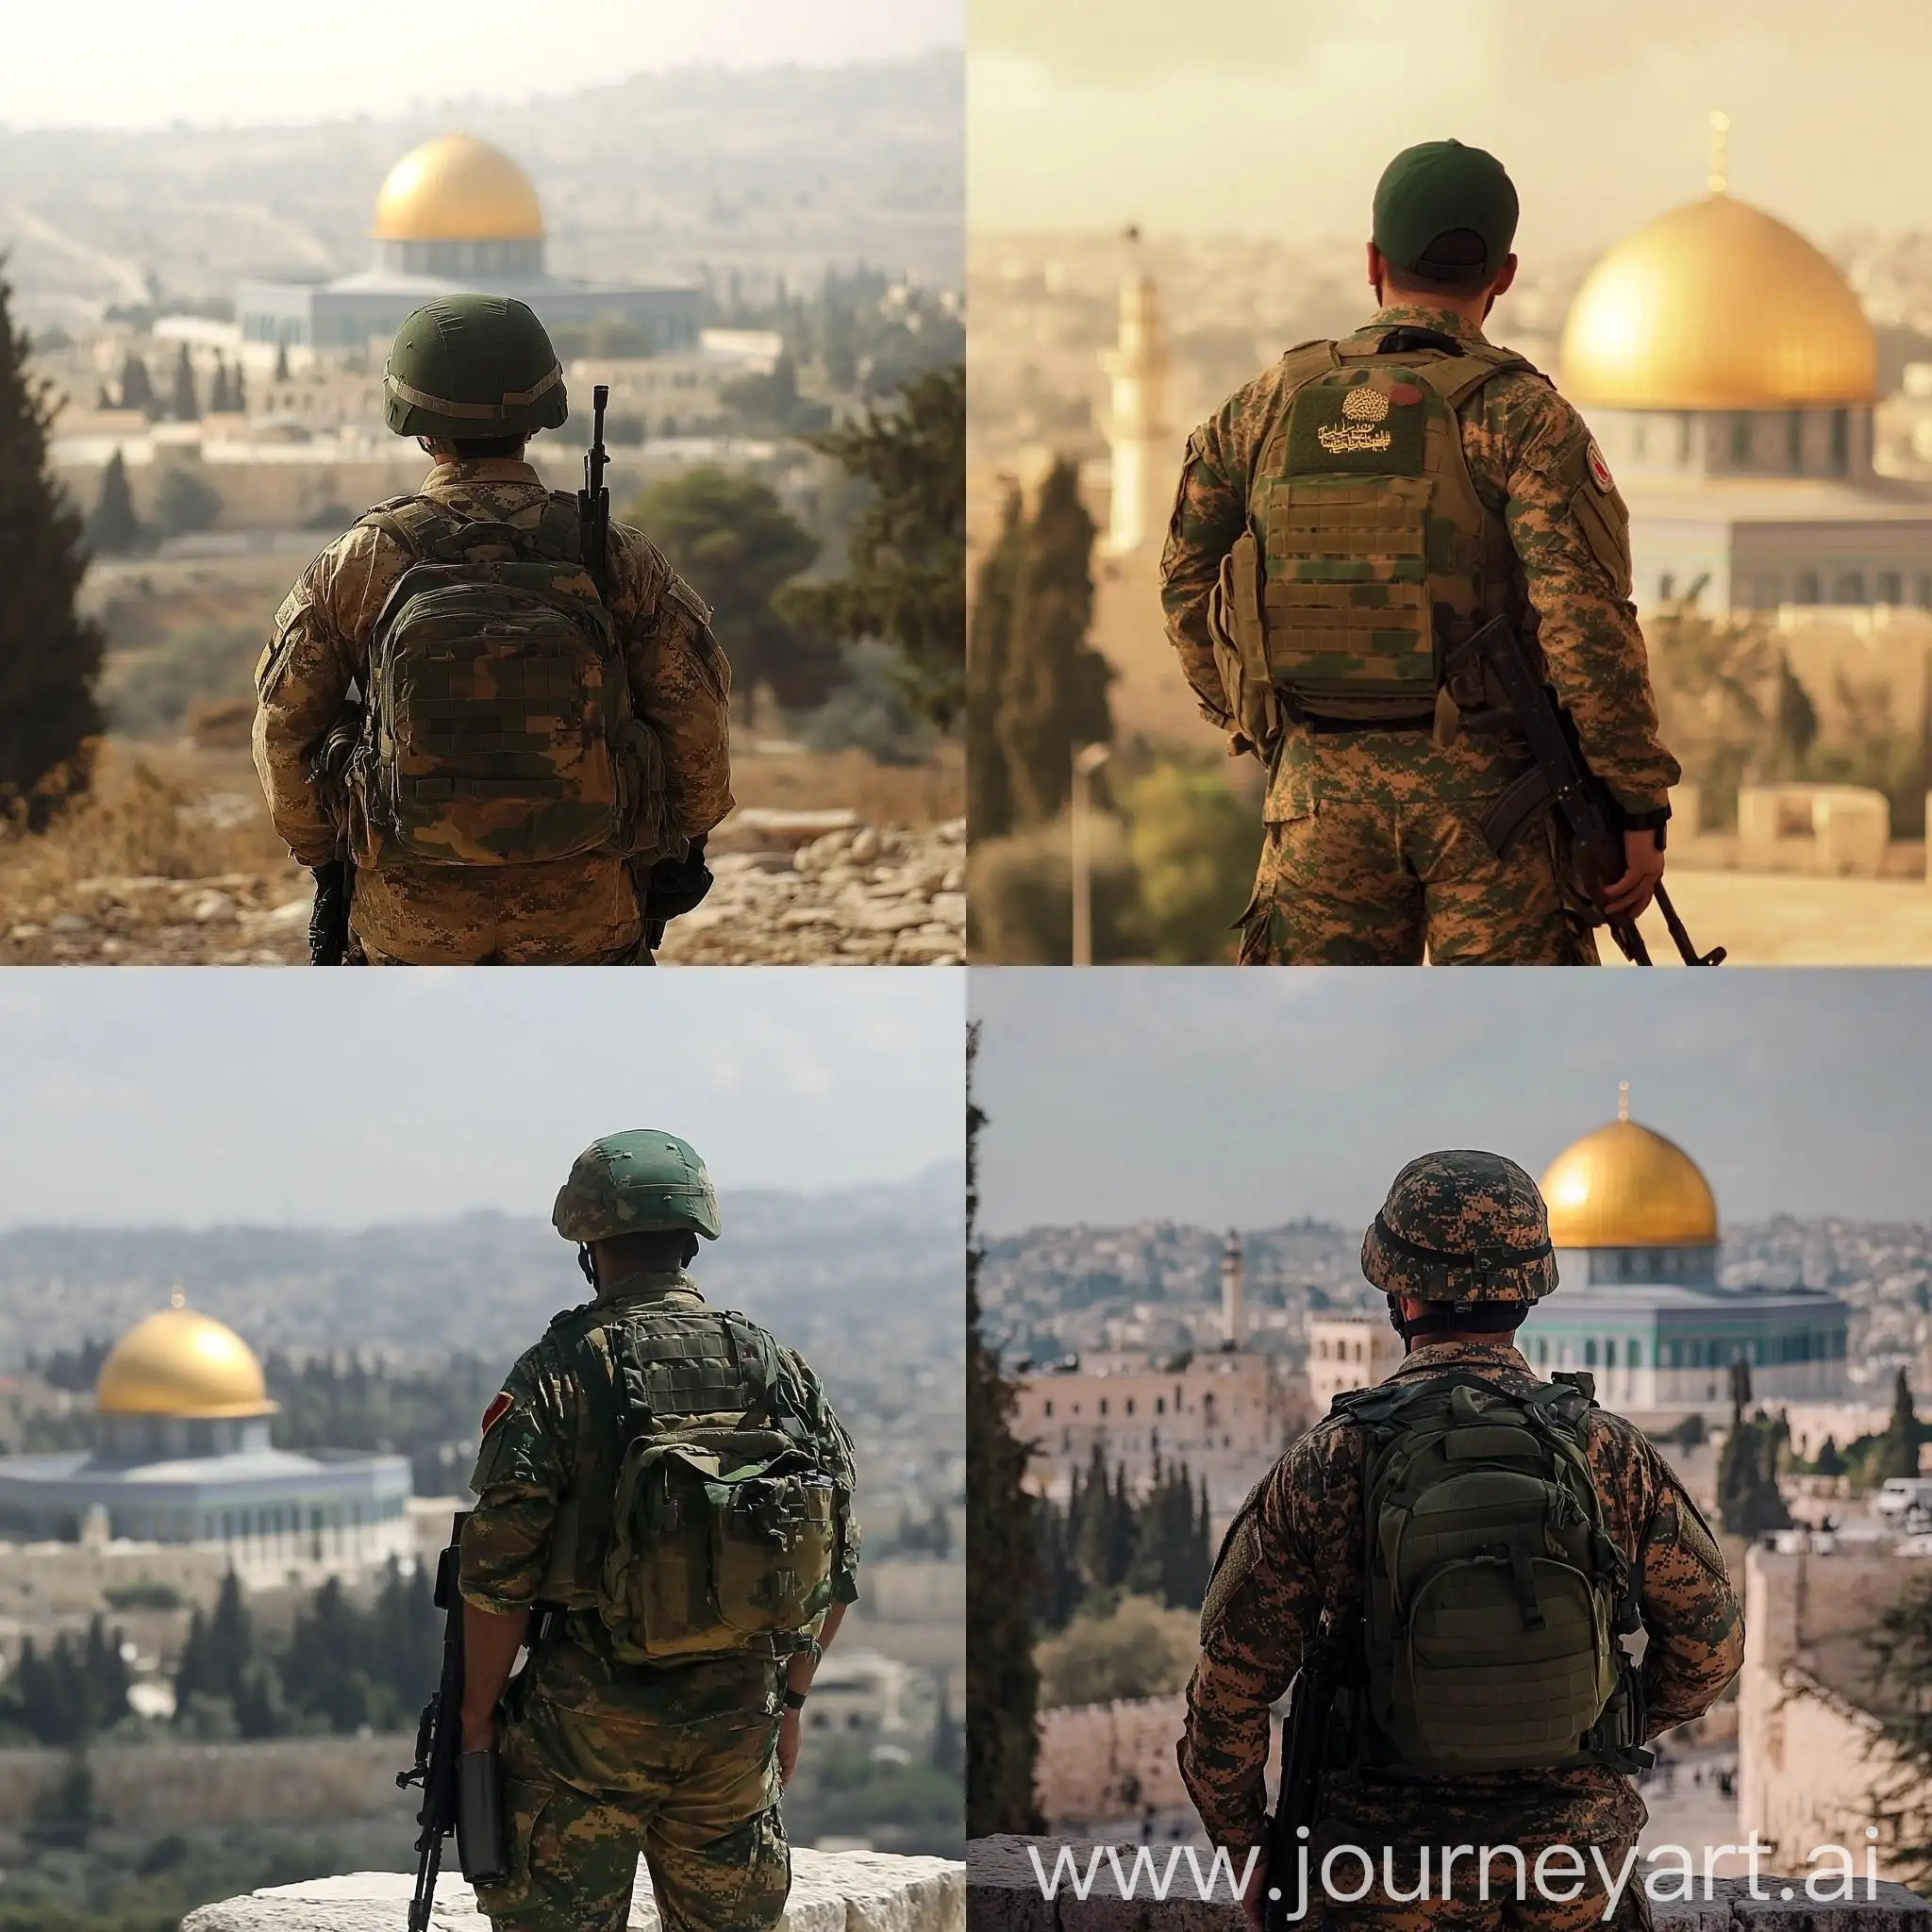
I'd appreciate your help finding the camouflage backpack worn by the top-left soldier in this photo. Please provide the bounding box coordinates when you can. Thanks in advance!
[346,494,665,870]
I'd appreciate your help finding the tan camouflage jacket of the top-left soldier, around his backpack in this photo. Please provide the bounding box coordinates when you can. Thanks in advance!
[255,458,732,869]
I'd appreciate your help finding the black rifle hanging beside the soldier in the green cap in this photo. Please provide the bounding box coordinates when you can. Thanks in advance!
[1451,616,1724,966]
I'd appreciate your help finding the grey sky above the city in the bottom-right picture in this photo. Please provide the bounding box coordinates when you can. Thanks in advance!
[970,966,1932,1235]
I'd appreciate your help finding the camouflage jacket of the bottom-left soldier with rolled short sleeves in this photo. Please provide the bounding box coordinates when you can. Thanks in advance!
[461,1272,859,1722]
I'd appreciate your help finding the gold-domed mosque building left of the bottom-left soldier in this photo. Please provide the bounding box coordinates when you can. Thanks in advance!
[0,1292,415,1586]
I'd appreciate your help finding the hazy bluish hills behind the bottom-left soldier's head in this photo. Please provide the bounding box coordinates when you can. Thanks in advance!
[0,1167,964,1368]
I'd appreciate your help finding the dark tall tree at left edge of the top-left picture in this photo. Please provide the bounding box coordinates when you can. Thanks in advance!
[0,282,103,829]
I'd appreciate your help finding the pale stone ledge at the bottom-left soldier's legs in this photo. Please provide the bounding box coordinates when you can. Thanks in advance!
[182,1851,966,1932]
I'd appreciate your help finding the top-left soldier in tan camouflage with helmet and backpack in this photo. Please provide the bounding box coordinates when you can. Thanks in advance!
[255,295,732,966]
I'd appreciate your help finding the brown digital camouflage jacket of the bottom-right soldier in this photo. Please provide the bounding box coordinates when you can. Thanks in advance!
[1180,1341,1744,1847]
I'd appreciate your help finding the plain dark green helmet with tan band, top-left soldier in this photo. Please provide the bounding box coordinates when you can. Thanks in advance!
[383,295,570,441]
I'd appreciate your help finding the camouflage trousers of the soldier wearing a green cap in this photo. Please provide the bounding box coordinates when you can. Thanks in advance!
[1241,798,1596,966]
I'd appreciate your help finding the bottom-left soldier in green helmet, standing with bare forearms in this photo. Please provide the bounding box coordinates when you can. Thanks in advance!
[459,1128,858,1932]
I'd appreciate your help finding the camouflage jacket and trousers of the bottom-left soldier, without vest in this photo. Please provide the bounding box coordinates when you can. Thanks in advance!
[461,1272,858,1932]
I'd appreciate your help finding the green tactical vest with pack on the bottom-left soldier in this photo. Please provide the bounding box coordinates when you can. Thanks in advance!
[541,1302,850,1663]
